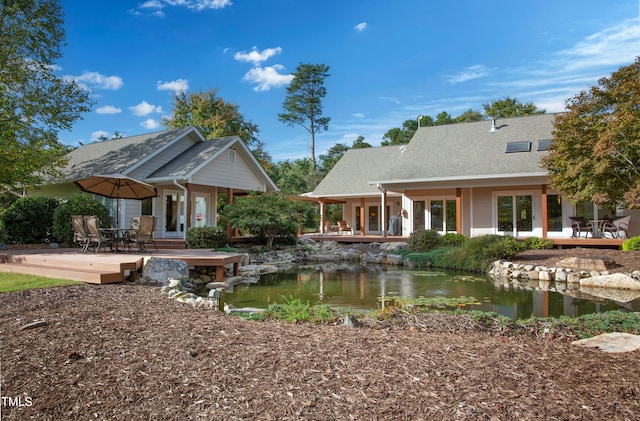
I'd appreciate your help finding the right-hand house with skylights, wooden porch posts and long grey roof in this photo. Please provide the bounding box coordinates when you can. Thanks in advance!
[307,114,640,238]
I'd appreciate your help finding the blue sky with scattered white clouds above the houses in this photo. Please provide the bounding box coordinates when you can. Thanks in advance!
[58,0,640,161]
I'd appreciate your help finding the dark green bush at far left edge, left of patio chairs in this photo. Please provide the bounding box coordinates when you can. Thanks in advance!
[2,196,59,244]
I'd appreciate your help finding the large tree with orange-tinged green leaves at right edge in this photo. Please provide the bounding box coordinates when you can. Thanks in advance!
[542,58,640,208]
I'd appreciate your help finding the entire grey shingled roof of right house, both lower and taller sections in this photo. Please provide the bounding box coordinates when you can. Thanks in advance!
[309,114,555,197]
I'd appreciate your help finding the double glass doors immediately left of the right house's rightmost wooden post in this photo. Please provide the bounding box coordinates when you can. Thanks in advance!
[496,194,534,237]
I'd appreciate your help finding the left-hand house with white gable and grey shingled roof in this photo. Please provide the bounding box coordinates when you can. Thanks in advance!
[28,127,278,238]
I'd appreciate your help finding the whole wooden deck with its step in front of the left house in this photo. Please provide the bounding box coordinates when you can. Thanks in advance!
[0,248,242,284]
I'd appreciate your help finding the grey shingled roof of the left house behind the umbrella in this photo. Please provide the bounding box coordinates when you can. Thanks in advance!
[62,127,199,181]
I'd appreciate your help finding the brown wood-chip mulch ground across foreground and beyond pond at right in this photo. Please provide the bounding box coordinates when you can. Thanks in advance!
[0,250,640,420]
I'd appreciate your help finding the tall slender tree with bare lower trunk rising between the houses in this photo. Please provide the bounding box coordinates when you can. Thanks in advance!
[278,63,331,169]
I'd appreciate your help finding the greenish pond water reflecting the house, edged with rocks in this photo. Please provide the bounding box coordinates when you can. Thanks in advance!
[225,265,640,320]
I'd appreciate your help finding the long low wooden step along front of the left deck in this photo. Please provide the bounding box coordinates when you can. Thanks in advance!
[0,263,123,284]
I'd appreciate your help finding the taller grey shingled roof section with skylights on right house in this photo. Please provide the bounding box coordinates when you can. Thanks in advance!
[370,114,555,183]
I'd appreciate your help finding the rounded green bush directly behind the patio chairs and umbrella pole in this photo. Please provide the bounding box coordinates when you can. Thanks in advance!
[53,193,111,245]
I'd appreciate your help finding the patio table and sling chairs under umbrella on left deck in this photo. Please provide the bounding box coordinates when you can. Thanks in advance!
[71,215,158,253]
